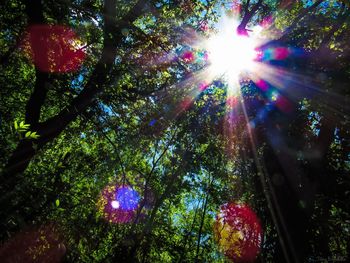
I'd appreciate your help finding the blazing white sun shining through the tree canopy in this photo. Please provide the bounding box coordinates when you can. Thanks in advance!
[206,16,258,84]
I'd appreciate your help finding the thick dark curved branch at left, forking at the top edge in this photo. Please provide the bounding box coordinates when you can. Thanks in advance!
[5,0,145,177]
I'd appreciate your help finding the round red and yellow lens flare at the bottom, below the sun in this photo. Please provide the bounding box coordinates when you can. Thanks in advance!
[214,203,262,263]
